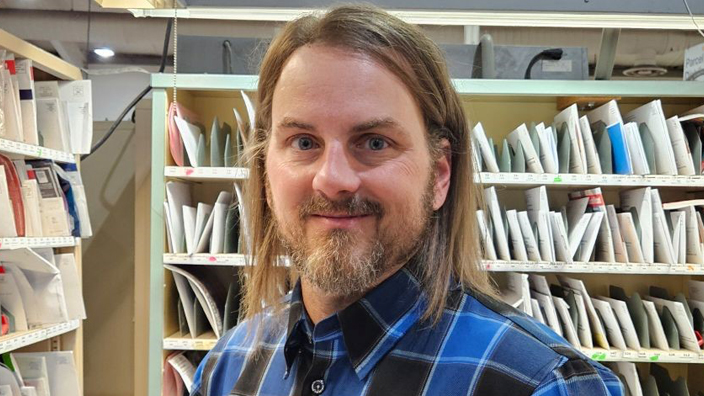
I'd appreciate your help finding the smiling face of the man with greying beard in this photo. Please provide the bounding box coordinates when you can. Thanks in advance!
[266,45,449,296]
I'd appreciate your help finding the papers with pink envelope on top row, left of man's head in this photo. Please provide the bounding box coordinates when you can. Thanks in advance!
[168,91,254,168]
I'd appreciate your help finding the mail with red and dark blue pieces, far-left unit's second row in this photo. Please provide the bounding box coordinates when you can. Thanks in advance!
[0,154,92,238]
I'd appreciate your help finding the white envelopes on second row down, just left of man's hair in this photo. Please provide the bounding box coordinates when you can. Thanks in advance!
[164,181,245,254]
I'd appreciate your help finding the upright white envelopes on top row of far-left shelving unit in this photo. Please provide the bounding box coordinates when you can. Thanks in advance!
[0,50,93,154]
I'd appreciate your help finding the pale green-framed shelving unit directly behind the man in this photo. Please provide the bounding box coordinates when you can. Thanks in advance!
[148,74,704,396]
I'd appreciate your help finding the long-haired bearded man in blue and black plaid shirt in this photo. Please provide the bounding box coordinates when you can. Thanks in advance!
[193,6,622,396]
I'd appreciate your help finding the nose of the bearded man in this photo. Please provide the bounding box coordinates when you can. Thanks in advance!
[313,142,360,199]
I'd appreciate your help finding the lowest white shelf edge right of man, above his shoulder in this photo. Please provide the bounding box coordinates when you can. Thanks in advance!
[580,348,704,364]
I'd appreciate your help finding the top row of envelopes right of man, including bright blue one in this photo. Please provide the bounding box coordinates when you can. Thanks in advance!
[472,100,704,176]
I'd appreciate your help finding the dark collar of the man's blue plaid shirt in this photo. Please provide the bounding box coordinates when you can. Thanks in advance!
[284,267,425,379]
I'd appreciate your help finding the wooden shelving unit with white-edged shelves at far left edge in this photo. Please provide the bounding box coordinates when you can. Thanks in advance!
[0,29,83,389]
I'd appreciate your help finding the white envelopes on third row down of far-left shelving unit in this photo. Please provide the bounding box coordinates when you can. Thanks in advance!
[0,248,86,335]
